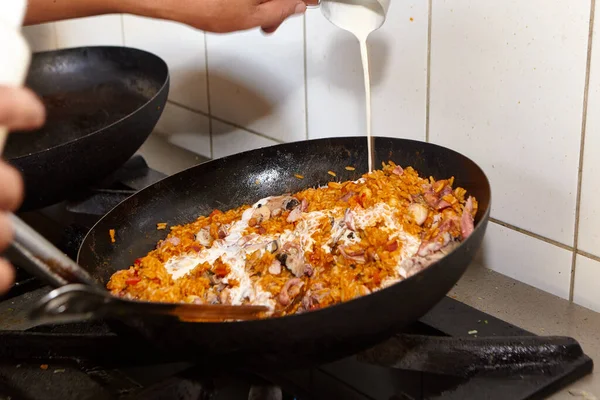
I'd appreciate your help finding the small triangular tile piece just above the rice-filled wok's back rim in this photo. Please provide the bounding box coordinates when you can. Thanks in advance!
[212,119,277,158]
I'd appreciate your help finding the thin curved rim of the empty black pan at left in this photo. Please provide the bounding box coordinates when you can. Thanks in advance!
[6,46,171,161]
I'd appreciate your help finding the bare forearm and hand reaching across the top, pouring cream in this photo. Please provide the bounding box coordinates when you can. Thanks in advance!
[24,0,313,32]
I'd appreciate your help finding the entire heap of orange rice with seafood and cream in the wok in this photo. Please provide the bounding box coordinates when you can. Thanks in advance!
[107,162,477,315]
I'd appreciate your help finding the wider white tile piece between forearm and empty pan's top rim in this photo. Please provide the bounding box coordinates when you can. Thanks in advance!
[56,15,123,48]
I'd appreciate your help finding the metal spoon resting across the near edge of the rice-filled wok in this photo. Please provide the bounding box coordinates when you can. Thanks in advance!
[30,284,269,324]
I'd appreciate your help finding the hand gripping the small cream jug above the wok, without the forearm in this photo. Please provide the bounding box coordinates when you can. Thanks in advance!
[149,0,318,33]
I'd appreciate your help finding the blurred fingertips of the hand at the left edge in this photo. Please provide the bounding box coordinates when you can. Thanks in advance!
[0,86,45,293]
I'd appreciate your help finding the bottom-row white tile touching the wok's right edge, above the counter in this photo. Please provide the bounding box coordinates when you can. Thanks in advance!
[476,222,572,299]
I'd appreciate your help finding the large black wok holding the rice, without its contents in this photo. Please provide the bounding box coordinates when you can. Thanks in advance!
[78,137,490,368]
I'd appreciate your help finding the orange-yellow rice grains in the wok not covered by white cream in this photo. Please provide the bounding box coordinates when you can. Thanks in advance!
[107,162,477,314]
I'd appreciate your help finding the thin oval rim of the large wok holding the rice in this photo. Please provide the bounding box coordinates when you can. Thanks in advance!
[77,136,492,326]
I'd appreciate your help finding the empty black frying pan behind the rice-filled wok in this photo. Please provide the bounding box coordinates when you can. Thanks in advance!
[4,47,169,211]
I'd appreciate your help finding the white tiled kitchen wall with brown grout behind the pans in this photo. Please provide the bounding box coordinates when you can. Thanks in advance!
[21,0,600,311]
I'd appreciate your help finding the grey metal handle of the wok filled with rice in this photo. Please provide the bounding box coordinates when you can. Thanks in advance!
[11,214,97,287]
